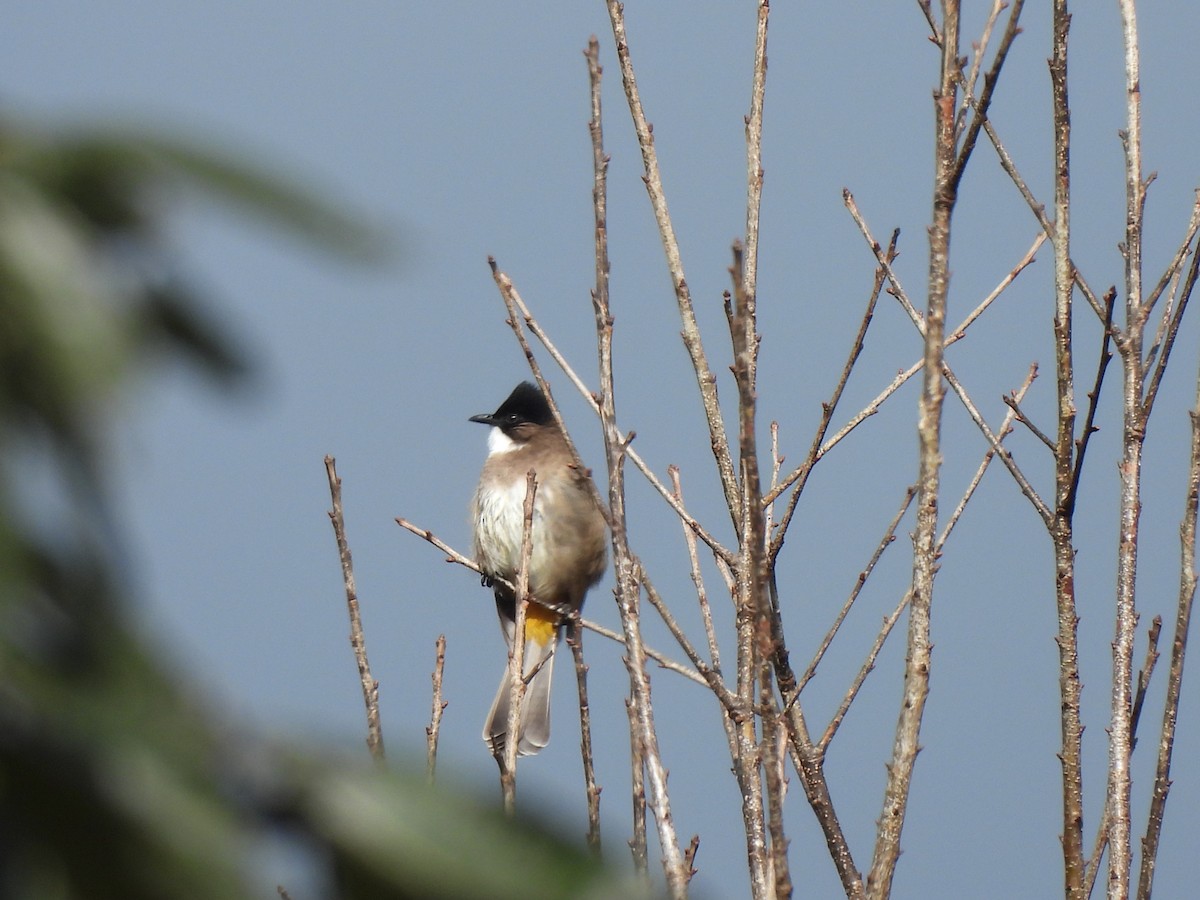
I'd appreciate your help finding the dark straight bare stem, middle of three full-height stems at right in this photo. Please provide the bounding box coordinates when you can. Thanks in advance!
[1050,0,1085,900]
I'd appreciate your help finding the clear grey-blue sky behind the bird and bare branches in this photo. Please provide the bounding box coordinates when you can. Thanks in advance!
[0,0,1200,899]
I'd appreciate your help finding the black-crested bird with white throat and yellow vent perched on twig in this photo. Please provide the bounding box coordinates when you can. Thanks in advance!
[469,382,607,767]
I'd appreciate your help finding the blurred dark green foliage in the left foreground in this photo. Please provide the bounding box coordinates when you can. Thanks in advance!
[0,120,636,900]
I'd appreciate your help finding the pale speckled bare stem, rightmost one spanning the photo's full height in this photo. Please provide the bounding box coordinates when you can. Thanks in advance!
[1108,0,1146,900]
